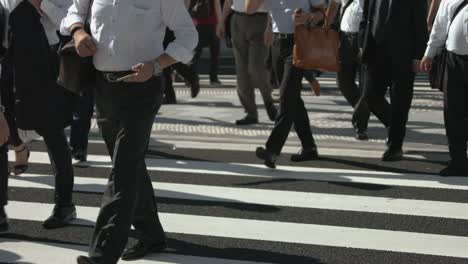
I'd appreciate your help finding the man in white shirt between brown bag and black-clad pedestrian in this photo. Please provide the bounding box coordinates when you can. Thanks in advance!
[329,0,370,140]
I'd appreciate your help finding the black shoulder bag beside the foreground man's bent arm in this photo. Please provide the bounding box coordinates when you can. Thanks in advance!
[57,1,96,95]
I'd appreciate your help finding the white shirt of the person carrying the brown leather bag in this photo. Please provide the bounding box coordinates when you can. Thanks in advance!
[265,0,326,34]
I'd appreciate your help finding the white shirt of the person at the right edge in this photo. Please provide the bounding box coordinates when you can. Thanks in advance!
[425,0,468,58]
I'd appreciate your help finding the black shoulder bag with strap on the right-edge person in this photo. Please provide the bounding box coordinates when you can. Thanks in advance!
[429,0,468,91]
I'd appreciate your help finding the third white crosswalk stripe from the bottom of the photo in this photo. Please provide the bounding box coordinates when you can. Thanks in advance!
[10,174,468,220]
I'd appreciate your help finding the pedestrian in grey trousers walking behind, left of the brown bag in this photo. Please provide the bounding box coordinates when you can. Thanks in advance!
[218,0,278,126]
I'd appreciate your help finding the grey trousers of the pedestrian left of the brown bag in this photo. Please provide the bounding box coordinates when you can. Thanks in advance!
[231,13,273,118]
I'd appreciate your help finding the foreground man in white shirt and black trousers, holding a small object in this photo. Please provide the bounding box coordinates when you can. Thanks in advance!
[62,0,198,264]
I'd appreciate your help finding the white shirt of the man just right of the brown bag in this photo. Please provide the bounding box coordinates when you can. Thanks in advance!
[335,0,364,33]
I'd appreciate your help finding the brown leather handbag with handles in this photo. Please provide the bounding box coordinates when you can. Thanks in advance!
[293,11,340,72]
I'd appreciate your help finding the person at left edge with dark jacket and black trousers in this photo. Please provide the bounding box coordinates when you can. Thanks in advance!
[0,0,76,229]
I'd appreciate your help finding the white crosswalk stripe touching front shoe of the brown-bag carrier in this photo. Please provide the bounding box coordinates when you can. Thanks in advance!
[9,152,468,190]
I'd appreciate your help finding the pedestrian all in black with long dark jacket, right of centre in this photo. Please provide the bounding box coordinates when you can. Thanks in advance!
[359,0,428,161]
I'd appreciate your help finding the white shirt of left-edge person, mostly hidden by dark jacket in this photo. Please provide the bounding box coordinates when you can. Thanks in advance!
[0,0,72,47]
